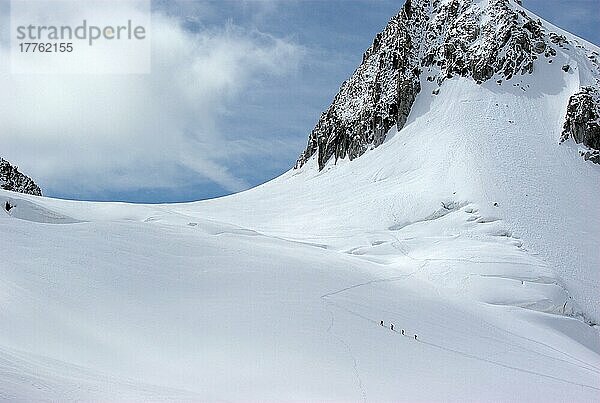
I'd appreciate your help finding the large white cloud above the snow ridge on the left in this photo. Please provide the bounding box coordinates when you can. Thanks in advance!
[0,3,304,195]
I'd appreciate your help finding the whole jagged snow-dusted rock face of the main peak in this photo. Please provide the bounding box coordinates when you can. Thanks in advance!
[295,0,592,169]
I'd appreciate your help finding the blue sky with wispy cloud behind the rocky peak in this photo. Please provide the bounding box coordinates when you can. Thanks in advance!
[0,0,600,203]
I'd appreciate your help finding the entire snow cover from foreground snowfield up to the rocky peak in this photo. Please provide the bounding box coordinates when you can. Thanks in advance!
[0,1,600,401]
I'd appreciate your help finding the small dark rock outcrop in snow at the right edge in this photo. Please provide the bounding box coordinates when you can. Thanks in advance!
[561,86,600,164]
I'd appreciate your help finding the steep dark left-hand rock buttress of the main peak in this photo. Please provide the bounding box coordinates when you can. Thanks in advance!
[296,1,427,169]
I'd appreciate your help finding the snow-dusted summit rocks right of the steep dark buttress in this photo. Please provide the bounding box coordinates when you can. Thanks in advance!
[422,0,547,84]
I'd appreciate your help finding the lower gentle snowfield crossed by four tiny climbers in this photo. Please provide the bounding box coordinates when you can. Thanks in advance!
[0,189,600,401]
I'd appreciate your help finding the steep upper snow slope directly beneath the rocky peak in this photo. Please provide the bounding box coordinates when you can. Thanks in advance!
[181,65,600,323]
